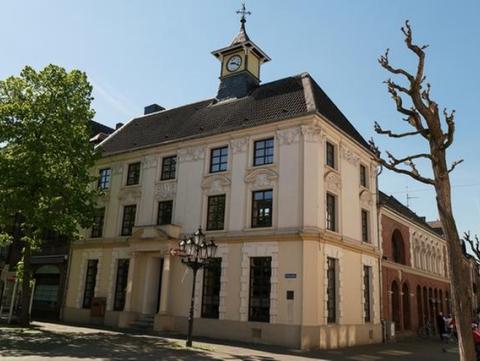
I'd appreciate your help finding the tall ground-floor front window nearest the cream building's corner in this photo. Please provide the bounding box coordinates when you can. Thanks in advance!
[248,257,272,322]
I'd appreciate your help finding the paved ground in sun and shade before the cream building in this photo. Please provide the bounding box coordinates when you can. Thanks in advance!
[0,322,458,361]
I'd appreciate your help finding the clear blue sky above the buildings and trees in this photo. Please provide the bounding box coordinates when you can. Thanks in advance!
[0,0,480,233]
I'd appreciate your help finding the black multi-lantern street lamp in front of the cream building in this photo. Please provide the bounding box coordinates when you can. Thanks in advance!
[172,227,217,347]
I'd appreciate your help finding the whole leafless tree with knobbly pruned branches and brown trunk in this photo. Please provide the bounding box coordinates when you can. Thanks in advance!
[371,20,475,361]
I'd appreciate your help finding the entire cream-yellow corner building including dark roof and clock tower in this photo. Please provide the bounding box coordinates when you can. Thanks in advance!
[63,9,382,349]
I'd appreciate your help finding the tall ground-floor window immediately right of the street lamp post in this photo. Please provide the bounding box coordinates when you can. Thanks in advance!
[202,258,222,318]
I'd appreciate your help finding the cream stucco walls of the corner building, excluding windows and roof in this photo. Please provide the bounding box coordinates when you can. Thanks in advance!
[64,116,381,348]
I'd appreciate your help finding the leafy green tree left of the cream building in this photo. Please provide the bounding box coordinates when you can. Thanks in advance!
[0,65,96,325]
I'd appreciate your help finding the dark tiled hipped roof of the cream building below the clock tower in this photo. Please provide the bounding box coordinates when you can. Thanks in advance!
[99,73,370,155]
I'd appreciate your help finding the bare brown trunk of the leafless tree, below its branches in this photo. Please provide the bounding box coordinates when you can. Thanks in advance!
[434,169,476,361]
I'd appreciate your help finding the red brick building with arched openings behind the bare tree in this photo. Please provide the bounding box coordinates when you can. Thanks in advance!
[379,192,450,333]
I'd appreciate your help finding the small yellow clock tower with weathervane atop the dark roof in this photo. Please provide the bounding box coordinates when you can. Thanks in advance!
[212,3,270,100]
